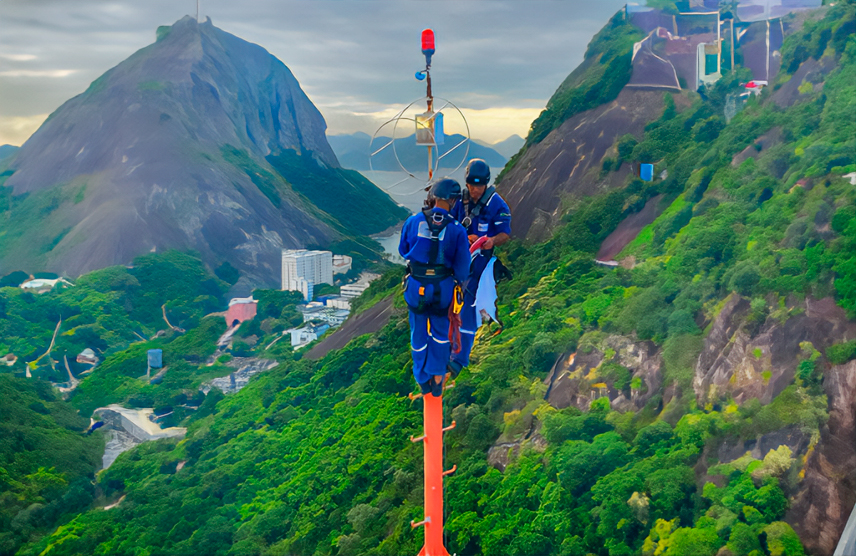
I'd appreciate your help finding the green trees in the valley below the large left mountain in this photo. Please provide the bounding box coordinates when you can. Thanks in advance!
[0,252,318,422]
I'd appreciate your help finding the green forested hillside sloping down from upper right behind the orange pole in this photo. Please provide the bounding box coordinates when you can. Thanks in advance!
[2,3,856,556]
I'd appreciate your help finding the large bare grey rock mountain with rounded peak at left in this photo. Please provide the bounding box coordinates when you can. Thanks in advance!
[0,16,407,285]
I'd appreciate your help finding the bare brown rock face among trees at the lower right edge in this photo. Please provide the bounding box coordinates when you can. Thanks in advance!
[693,294,856,554]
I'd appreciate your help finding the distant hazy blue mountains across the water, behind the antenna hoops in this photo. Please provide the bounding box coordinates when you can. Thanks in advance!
[327,132,508,173]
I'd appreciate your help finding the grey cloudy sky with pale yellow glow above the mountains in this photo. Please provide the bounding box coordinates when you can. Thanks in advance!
[0,0,624,145]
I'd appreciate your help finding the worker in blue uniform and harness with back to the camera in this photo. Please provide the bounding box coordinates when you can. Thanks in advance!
[398,178,470,397]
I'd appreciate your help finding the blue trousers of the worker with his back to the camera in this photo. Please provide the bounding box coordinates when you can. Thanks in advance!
[410,310,452,384]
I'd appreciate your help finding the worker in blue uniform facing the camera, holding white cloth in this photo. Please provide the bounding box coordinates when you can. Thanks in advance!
[448,158,511,378]
